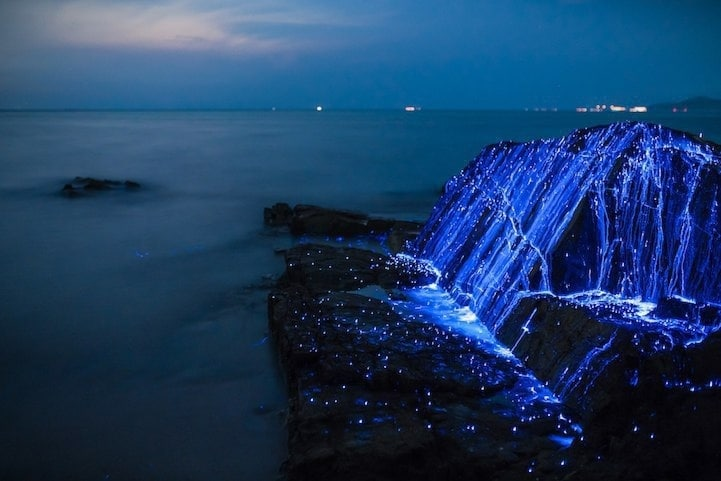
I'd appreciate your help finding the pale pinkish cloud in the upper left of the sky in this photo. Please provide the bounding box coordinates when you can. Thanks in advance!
[16,0,380,55]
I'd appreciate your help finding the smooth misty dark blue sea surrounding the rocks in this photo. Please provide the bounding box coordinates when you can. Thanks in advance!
[0,110,721,481]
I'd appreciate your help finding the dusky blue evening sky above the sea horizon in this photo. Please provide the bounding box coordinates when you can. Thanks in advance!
[0,0,721,109]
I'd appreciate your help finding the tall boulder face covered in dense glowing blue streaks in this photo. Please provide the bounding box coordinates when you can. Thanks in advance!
[412,122,721,332]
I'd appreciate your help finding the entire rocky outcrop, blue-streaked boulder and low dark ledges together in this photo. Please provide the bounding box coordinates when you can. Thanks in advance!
[266,123,721,481]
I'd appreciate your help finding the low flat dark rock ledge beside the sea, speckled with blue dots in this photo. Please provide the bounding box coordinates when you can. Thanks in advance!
[268,245,571,481]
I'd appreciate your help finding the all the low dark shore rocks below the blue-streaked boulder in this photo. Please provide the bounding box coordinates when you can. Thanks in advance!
[265,204,721,481]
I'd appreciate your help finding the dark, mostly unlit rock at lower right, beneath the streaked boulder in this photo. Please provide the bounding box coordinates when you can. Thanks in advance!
[497,294,721,480]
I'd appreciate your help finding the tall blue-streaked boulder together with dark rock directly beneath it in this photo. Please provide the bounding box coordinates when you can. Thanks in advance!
[404,122,721,479]
